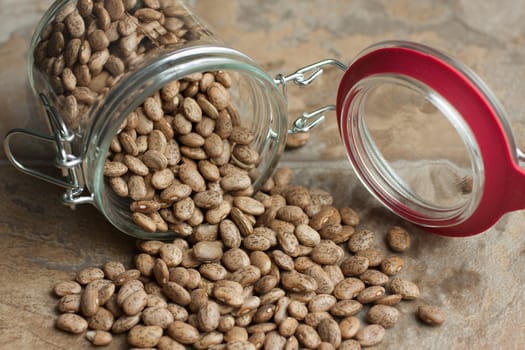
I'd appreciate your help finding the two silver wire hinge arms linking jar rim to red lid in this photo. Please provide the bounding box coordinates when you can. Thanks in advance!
[274,59,348,134]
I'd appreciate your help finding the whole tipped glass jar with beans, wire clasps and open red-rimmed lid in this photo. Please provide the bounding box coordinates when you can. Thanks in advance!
[4,0,525,239]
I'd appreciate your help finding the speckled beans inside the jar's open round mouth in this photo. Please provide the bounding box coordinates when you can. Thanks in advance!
[104,67,262,237]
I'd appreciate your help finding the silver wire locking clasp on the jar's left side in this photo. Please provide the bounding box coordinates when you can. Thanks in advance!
[4,94,94,209]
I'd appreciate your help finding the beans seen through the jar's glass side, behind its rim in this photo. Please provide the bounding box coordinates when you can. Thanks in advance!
[34,0,208,129]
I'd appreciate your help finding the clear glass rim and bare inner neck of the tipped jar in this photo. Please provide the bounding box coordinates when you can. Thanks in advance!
[83,43,287,239]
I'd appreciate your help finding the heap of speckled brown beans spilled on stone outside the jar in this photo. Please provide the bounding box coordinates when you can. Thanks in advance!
[54,168,445,350]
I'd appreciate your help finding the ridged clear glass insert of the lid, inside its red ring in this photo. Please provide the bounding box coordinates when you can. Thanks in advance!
[340,74,485,227]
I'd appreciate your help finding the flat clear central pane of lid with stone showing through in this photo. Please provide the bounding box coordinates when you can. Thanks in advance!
[361,83,473,209]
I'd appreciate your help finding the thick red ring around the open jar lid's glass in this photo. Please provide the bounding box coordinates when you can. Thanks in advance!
[337,42,525,237]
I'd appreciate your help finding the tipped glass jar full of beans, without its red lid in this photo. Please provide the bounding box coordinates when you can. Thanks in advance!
[9,0,287,238]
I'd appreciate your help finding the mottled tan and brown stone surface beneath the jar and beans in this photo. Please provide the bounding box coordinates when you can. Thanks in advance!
[0,0,525,349]
